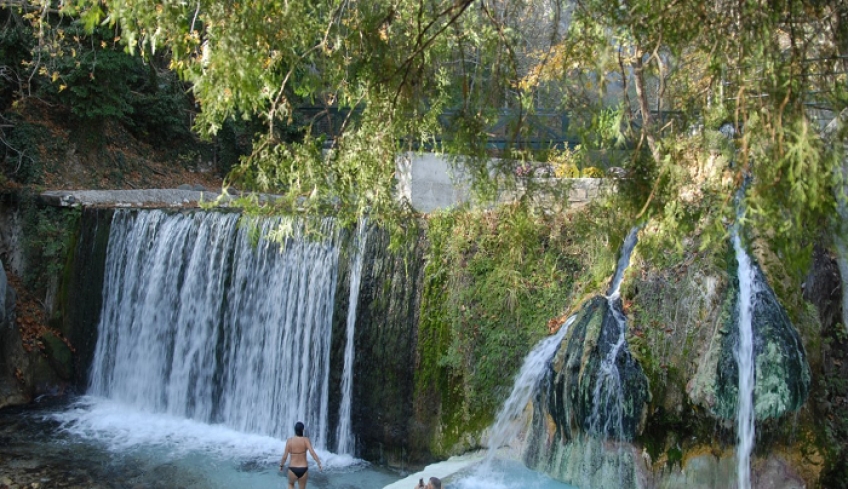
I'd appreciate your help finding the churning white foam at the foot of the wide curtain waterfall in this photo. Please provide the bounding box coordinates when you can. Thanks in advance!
[45,396,399,489]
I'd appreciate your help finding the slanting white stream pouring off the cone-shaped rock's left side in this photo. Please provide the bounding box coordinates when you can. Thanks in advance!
[486,315,577,461]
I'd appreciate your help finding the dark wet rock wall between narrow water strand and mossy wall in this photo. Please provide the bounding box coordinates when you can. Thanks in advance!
[330,229,424,466]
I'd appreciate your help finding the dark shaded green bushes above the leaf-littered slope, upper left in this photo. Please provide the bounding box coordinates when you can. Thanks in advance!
[0,2,204,183]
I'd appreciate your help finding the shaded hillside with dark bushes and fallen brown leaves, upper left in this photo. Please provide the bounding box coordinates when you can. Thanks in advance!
[0,4,256,190]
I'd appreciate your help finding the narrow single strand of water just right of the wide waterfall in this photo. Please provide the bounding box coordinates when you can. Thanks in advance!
[336,220,368,455]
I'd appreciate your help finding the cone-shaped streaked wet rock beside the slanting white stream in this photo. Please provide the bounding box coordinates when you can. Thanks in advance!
[525,297,650,487]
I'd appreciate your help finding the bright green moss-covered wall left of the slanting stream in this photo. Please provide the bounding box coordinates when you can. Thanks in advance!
[416,200,623,450]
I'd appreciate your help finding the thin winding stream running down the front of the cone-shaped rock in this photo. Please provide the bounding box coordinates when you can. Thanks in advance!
[589,226,639,437]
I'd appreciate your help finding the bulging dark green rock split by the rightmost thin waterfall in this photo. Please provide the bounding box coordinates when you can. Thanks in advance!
[692,258,810,420]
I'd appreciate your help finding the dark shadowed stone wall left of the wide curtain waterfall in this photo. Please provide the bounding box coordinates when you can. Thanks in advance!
[0,198,111,407]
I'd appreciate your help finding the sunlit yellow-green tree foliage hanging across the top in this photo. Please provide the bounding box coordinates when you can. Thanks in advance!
[49,0,846,264]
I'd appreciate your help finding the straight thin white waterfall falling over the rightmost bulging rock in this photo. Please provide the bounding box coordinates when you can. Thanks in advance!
[733,229,756,489]
